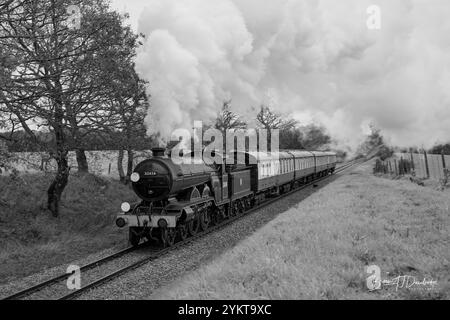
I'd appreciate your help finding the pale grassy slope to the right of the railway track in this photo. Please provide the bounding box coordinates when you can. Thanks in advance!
[151,165,450,299]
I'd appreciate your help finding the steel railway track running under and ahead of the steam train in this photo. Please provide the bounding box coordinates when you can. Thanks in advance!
[3,160,363,300]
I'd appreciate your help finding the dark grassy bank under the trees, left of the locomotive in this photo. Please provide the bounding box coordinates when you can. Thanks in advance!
[0,174,135,282]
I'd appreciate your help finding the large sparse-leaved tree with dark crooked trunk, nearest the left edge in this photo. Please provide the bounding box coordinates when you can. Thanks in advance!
[0,0,139,216]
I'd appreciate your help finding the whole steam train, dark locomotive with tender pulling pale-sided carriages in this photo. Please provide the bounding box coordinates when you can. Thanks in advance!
[116,148,336,246]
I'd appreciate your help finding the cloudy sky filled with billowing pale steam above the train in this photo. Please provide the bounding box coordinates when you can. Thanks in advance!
[112,0,450,151]
